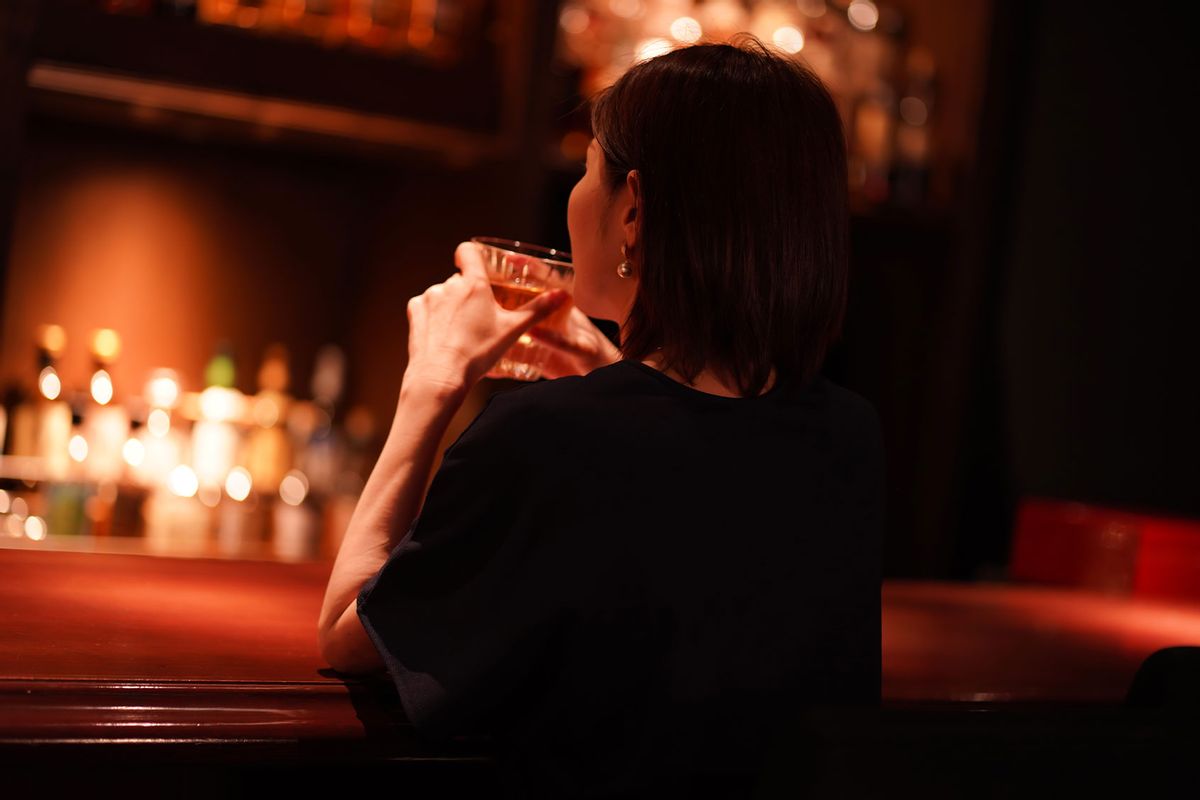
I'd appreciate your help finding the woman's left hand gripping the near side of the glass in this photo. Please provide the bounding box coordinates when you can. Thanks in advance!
[404,242,568,392]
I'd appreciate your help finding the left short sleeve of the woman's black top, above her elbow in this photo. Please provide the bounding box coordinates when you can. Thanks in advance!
[358,390,563,736]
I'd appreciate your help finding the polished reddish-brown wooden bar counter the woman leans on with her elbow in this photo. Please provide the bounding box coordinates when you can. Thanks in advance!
[0,551,1200,759]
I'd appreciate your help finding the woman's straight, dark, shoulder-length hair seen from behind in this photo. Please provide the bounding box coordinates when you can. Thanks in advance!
[592,35,848,396]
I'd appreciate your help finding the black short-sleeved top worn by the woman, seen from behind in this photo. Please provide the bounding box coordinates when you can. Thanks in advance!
[358,361,884,796]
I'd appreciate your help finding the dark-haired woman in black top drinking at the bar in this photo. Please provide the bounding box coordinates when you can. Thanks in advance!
[319,35,883,796]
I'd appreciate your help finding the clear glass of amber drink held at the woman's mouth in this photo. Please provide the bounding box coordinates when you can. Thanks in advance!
[470,236,575,380]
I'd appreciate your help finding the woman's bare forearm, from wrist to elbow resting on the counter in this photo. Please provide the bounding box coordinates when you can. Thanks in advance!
[318,375,467,672]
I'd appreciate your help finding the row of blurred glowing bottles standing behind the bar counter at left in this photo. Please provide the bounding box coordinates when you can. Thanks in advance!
[0,325,374,561]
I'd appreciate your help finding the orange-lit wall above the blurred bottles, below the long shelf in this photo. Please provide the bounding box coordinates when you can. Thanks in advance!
[0,119,536,455]
